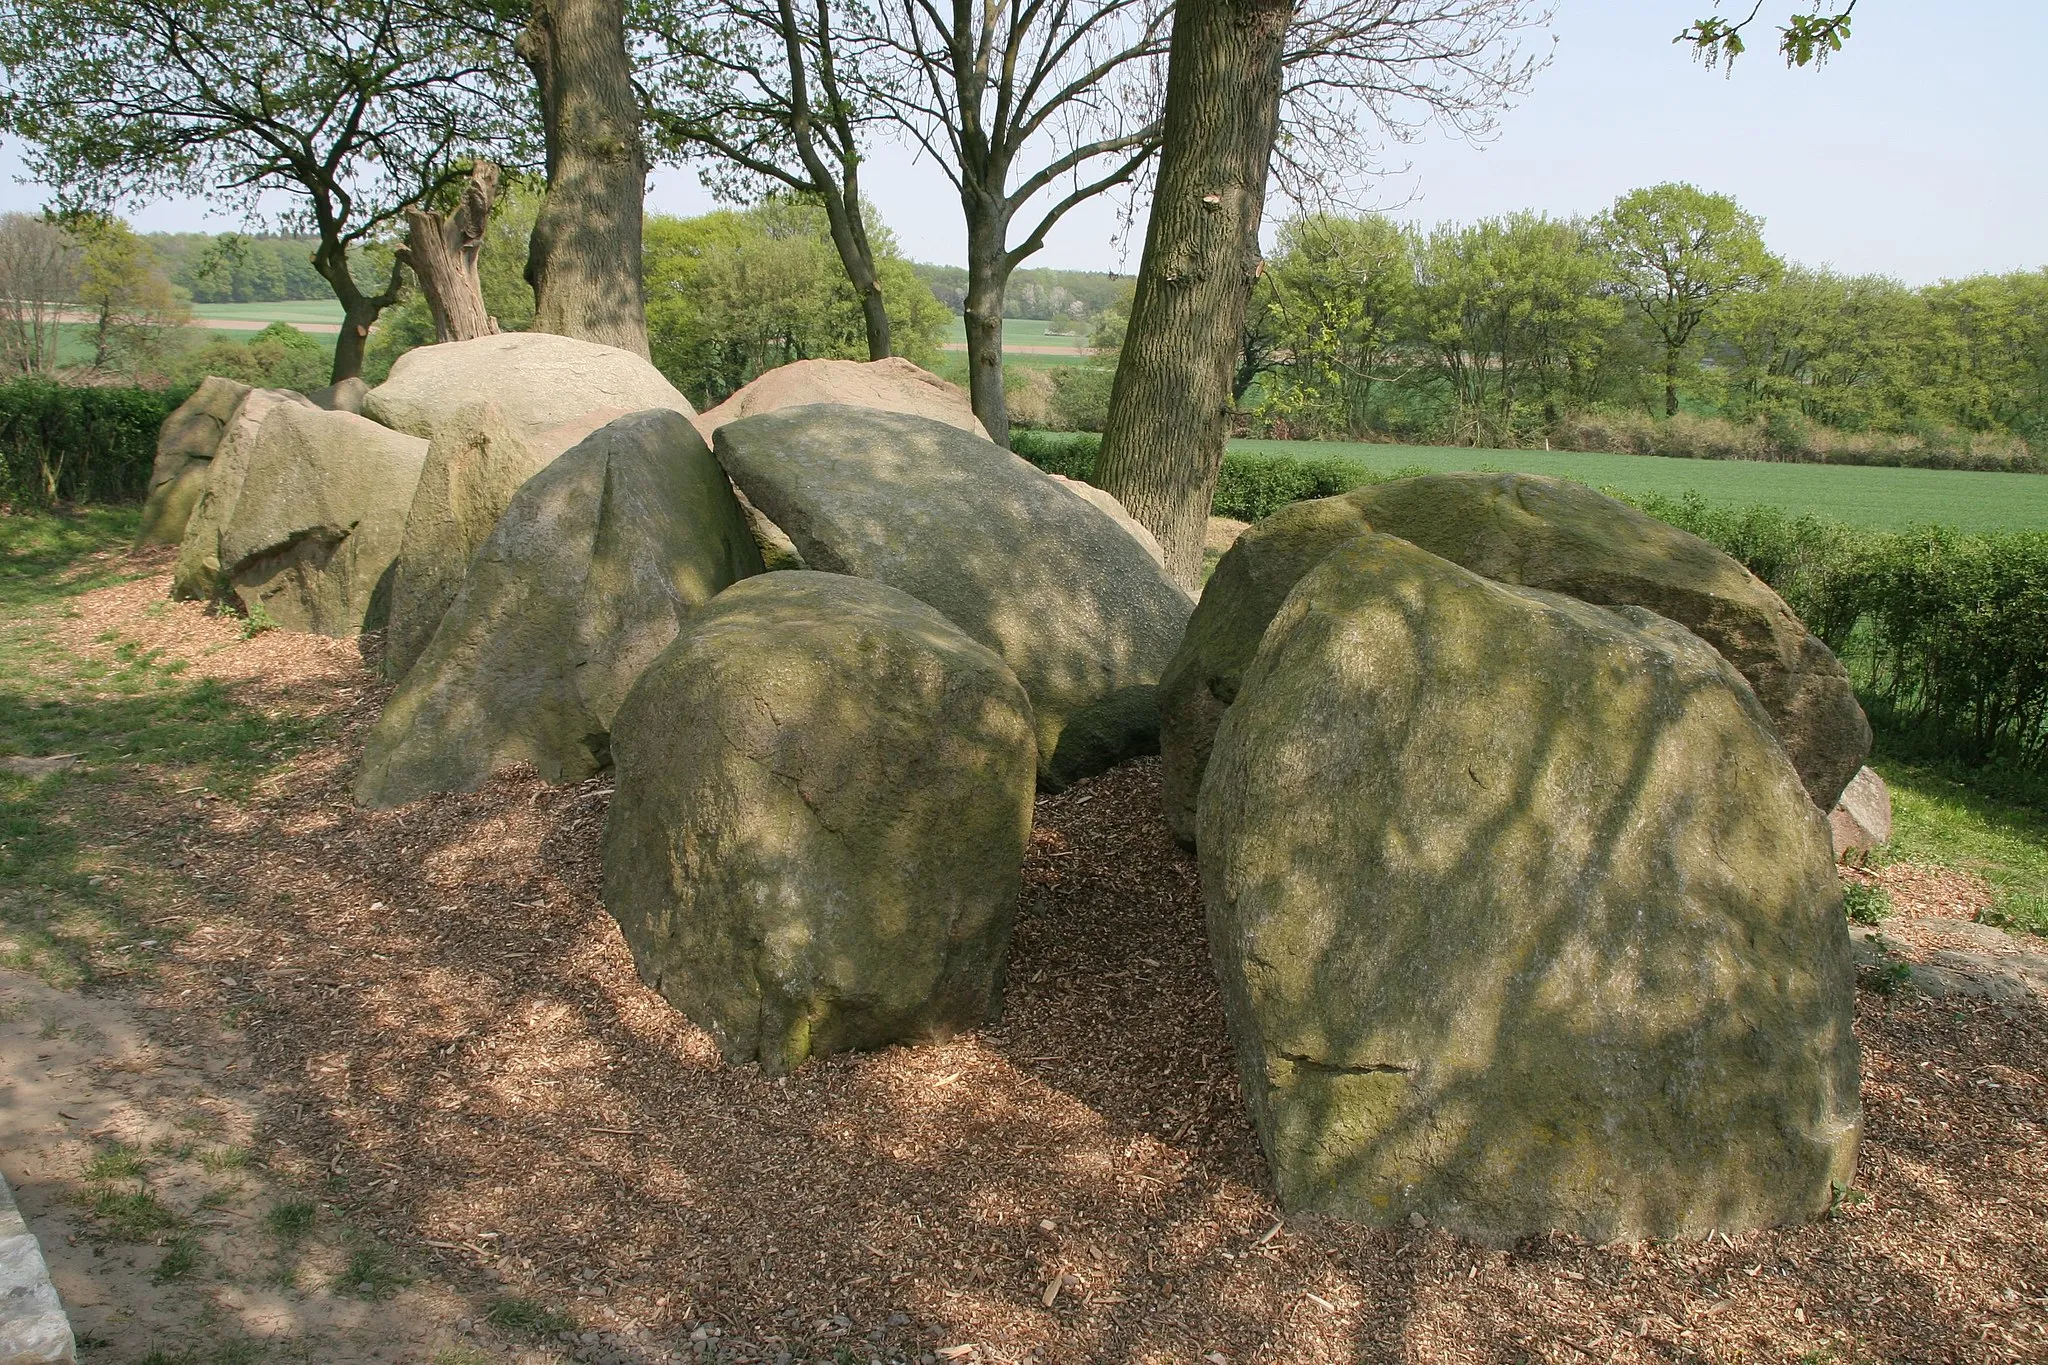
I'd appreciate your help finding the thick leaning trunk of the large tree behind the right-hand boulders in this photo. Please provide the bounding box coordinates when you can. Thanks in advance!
[1096,0,1294,591]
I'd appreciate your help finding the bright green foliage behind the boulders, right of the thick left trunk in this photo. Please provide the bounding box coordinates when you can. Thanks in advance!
[645,199,946,407]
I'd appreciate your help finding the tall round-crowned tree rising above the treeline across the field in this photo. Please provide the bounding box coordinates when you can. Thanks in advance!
[1597,184,1780,417]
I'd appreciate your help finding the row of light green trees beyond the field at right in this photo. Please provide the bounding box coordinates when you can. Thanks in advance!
[1187,186,2048,469]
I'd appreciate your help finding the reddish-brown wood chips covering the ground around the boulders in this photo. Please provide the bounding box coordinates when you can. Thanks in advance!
[8,548,2048,1365]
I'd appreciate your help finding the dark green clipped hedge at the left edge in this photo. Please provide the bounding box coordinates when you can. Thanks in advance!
[0,379,193,508]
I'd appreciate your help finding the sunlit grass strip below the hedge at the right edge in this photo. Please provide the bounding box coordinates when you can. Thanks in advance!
[1870,733,2048,935]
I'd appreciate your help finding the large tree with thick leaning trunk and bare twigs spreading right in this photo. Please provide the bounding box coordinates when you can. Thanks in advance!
[1096,0,1550,587]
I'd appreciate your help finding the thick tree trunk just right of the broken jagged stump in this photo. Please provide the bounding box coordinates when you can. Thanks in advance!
[518,0,647,356]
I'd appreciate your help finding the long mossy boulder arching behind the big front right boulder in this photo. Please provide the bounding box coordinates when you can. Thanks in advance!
[1159,473,1870,841]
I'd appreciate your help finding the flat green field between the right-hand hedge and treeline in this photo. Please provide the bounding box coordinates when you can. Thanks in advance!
[1231,440,2048,530]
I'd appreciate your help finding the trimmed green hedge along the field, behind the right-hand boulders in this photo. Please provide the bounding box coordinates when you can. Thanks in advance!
[1016,432,2048,767]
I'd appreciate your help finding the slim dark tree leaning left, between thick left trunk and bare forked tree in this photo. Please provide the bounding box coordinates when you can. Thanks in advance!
[641,0,893,360]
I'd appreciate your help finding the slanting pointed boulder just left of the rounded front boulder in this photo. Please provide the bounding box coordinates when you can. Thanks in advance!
[356,409,762,806]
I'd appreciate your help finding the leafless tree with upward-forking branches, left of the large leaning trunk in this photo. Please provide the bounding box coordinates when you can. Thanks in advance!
[842,0,1171,444]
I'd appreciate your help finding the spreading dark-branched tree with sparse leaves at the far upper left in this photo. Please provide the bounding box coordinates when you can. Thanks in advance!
[0,0,536,379]
